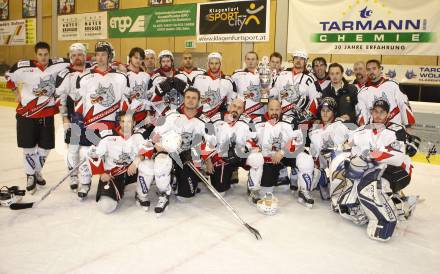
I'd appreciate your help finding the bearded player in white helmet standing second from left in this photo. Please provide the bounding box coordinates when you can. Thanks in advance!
[56,43,90,192]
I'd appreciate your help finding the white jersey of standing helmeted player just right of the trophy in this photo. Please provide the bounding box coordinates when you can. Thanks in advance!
[270,69,320,116]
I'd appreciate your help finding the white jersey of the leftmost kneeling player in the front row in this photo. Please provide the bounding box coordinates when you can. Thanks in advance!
[89,130,145,176]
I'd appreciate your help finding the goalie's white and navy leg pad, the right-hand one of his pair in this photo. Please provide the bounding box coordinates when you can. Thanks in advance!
[357,168,397,241]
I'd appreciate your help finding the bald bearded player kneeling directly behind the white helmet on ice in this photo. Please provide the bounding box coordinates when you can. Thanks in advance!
[251,99,304,205]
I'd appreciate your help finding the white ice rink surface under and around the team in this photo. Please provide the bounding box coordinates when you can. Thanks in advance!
[0,107,440,274]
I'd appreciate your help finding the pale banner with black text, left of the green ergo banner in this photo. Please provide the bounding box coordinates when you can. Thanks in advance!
[58,12,107,40]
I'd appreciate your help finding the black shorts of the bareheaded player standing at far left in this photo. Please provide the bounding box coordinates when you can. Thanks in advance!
[15,114,55,149]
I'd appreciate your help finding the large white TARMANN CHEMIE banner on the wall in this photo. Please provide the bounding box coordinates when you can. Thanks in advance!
[288,0,440,55]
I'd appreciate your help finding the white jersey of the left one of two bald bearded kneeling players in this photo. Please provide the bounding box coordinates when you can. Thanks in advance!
[211,112,257,153]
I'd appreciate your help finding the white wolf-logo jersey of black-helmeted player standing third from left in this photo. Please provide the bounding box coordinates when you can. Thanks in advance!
[75,67,130,129]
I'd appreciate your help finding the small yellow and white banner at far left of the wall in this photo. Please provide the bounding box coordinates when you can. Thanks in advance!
[0,18,37,46]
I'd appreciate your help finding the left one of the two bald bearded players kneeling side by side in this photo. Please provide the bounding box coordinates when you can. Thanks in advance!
[206,98,264,197]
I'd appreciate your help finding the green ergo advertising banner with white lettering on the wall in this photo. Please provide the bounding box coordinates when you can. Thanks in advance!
[108,4,197,38]
